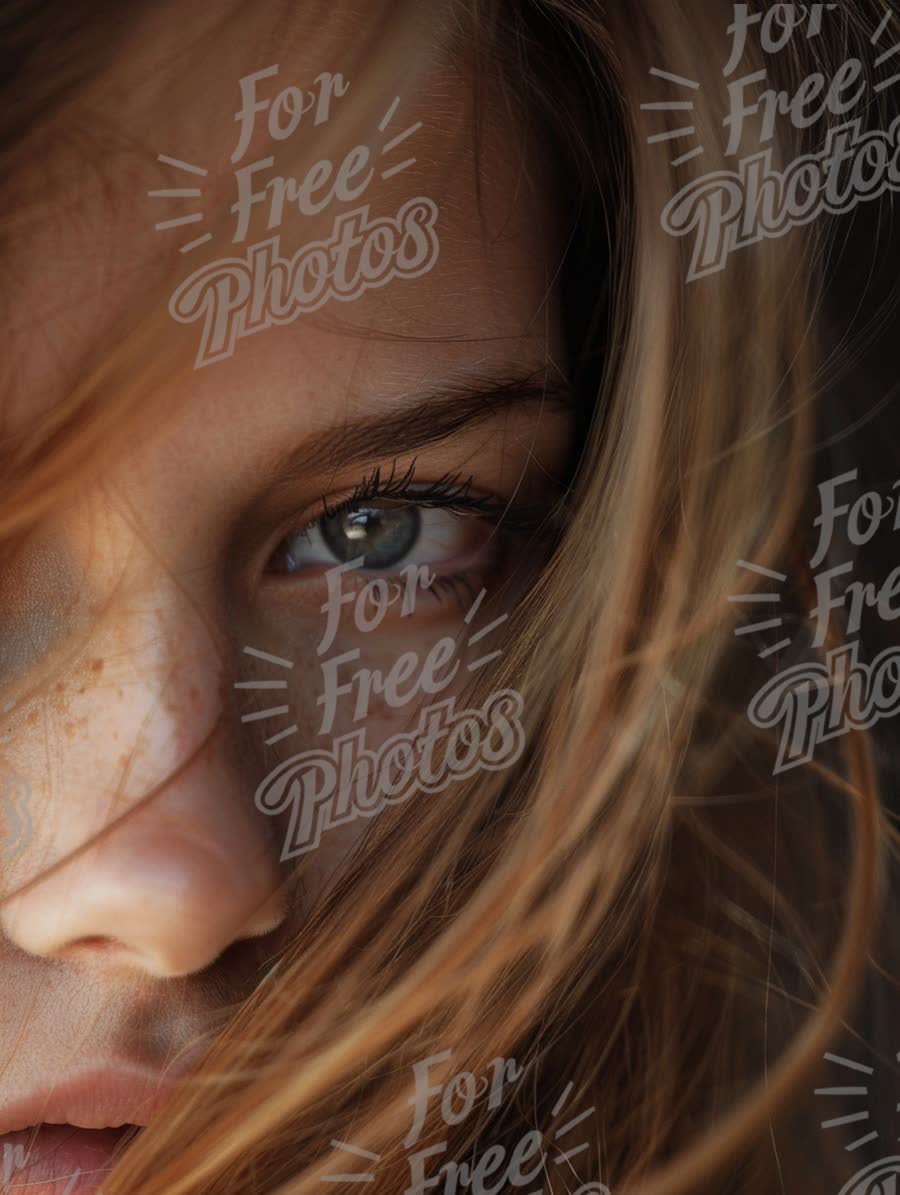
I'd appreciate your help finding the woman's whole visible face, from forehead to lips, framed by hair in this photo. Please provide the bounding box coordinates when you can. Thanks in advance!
[0,2,569,1195]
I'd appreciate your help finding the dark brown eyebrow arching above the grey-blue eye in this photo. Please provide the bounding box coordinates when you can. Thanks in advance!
[270,370,575,486]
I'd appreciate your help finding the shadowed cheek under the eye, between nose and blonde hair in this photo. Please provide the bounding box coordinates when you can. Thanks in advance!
[236,590,502,899]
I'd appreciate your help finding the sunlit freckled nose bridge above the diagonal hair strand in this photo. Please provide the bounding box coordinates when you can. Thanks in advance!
[0,602,221,891]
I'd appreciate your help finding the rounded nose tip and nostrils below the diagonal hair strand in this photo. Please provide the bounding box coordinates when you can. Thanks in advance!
[2,761,283,978]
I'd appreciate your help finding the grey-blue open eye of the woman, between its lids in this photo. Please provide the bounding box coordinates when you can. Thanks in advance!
[270,504,473,574]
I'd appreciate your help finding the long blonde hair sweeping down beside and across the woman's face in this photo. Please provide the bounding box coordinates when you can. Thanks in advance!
[4,0,888,1195]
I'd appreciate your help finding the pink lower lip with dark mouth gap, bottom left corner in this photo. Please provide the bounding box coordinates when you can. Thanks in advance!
[0,1124,134,1195]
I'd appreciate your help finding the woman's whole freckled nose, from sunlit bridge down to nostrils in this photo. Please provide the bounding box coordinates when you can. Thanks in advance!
[0,583,284,978]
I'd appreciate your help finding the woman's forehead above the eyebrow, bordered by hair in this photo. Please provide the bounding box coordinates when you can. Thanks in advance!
[6,0,556,427]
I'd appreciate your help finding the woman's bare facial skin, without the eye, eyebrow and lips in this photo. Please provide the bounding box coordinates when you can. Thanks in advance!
[0,0,569,1180]
